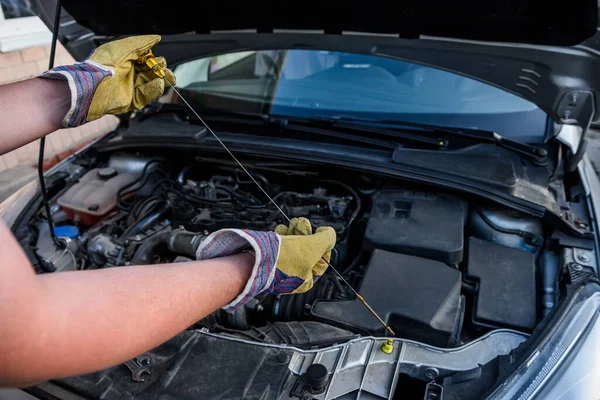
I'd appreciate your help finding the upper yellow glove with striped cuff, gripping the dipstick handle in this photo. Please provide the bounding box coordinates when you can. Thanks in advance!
[41,35,175,128]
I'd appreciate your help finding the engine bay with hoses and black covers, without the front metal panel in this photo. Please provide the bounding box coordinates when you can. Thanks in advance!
[32,154,544,347]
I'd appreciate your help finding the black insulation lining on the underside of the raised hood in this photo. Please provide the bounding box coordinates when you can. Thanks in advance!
[48,0,597,46]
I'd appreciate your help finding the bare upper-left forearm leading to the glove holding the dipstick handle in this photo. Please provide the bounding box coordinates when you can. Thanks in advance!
[0,78,71,154]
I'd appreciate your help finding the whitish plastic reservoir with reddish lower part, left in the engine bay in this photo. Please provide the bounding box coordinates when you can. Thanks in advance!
[57,168,137,225]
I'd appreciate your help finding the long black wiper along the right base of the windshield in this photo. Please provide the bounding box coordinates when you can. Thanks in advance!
[311,115,548,165]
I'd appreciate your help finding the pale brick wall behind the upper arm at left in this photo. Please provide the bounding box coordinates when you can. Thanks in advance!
[0,43,116,172]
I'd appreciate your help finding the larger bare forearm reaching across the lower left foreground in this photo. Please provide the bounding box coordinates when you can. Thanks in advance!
[0,254,253,384]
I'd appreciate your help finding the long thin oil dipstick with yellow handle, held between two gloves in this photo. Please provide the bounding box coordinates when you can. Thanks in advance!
[138,50,396,336]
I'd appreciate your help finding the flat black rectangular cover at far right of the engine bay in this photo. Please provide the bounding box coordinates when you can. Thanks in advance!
[467,237,536,331]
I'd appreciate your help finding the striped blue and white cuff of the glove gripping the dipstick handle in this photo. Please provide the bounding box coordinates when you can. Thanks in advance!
[40,60,114,128]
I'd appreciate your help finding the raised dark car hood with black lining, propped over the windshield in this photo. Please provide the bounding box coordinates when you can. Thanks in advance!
[37,0,600,129]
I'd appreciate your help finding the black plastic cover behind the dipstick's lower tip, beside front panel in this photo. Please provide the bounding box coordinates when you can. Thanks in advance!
[311,250,464,346]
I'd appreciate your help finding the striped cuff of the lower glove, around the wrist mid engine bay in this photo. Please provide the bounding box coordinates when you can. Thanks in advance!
[196,229,281,310]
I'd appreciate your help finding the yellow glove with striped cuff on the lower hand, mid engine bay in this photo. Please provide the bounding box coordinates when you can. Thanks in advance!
[196,218,336,309]
